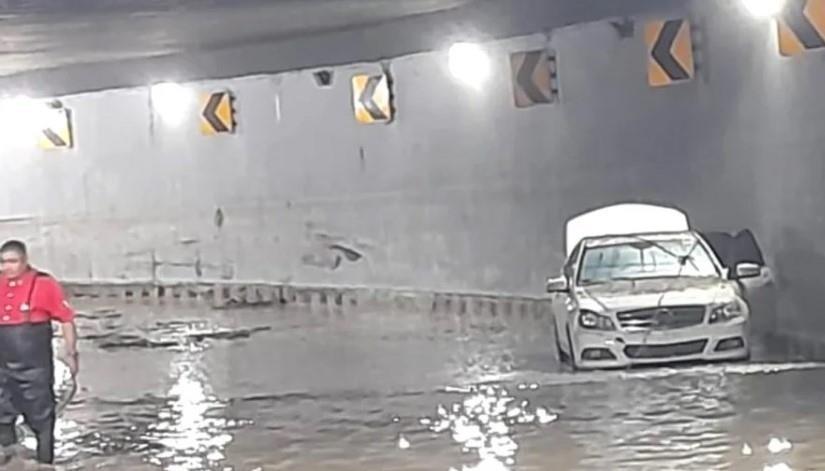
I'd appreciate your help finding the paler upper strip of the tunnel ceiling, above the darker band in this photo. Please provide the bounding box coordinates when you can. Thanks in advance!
[0,0,473,75]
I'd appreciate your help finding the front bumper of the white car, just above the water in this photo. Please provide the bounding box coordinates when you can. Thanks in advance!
[573,319,750,369]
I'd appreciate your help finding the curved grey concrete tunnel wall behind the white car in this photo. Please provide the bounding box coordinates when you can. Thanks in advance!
[0,2,825,338]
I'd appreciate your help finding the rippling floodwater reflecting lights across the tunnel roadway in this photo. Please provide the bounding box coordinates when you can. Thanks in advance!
[12,305,825,471]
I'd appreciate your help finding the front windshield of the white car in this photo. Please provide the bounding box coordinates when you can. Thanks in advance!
[579,237,719,284]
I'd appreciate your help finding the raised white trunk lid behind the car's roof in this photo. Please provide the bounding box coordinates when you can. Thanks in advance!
[565,203,690,255]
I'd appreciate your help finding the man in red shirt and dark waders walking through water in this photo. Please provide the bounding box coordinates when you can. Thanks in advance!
[0,240,79,464]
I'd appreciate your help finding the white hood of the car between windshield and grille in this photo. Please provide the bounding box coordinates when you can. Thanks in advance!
[576,277,738,311]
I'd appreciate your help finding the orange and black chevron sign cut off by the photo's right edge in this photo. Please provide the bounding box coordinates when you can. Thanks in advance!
[776,0,825,57]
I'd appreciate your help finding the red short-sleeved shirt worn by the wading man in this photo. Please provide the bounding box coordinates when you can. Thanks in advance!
[0,269,74,325]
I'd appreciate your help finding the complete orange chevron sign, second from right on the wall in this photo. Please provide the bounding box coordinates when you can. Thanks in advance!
[645,19,696,87]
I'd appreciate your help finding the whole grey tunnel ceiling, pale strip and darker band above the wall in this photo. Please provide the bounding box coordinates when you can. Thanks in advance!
[0,0,685,94]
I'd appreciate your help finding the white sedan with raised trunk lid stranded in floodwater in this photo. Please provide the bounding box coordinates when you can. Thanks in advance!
[547,205,762,369]
